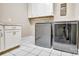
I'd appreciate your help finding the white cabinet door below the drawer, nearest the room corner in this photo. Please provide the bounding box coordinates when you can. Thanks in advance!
[5,30,21,49]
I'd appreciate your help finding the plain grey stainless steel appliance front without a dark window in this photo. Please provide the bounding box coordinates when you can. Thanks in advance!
[35,23,51,48]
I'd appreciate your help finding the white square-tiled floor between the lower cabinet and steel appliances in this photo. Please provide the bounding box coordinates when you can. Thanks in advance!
[1,36,79,56]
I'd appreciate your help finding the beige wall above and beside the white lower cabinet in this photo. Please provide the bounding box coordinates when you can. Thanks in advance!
[0,3,32,37]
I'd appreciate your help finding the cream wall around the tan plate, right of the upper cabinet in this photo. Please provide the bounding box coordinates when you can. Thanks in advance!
[54,3,75,21]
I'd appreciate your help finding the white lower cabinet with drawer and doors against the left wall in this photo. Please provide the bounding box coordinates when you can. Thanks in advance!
[0,25,21,52]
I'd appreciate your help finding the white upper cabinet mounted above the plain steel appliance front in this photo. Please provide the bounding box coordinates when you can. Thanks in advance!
[28,3,53,18]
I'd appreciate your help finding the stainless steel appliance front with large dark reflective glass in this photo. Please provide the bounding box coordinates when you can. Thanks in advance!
[53,22,78,53]
